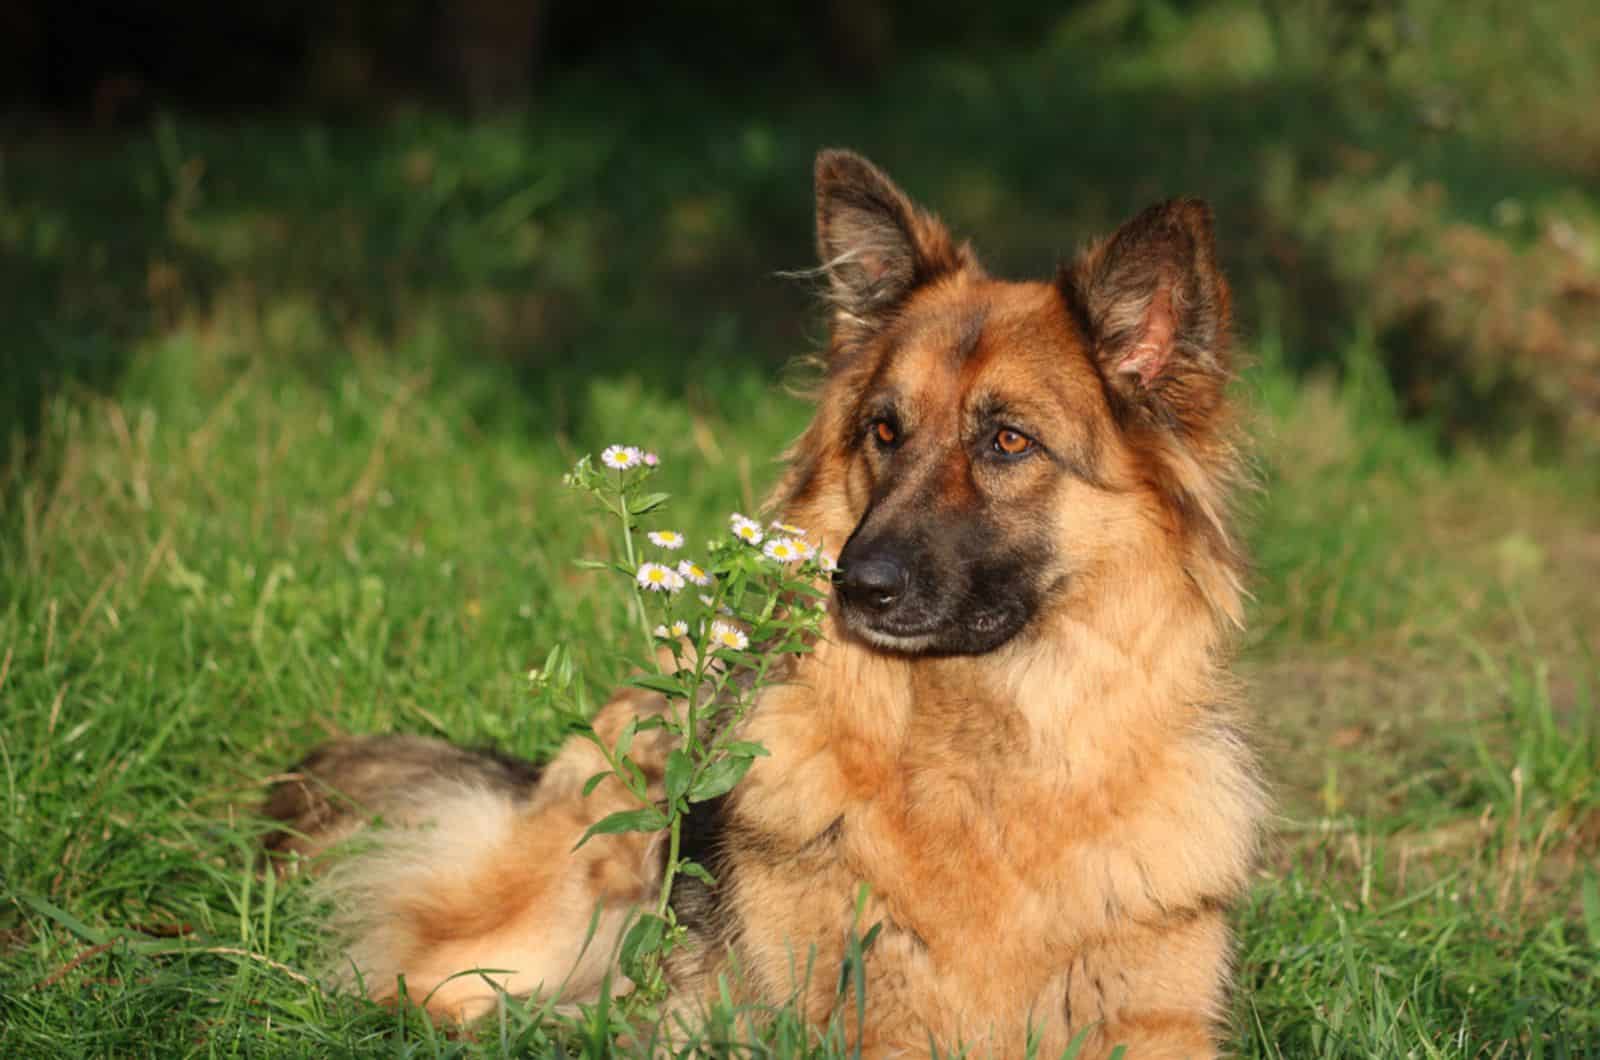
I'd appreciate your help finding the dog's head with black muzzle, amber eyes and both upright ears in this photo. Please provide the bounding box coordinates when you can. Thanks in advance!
[779,151,1240,653]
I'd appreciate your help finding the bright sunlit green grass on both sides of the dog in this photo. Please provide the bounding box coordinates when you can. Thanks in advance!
[0,293,1600,1055]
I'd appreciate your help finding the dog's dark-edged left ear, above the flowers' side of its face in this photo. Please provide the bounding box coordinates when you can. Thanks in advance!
[816,151,976,338]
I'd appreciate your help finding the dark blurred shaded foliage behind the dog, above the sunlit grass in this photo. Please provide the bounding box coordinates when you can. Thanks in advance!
[0,0,1600,464]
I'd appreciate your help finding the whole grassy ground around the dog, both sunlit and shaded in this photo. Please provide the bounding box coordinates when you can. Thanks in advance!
[0,5,1600,1057]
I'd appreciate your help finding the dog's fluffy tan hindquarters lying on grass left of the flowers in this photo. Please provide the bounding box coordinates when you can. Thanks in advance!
[266,703,664,1020]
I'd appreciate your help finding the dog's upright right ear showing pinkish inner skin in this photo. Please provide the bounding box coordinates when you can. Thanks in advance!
[1061,199,1230,431]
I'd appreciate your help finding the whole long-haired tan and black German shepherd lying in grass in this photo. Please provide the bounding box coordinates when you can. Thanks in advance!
[267,151,1264,1057]
